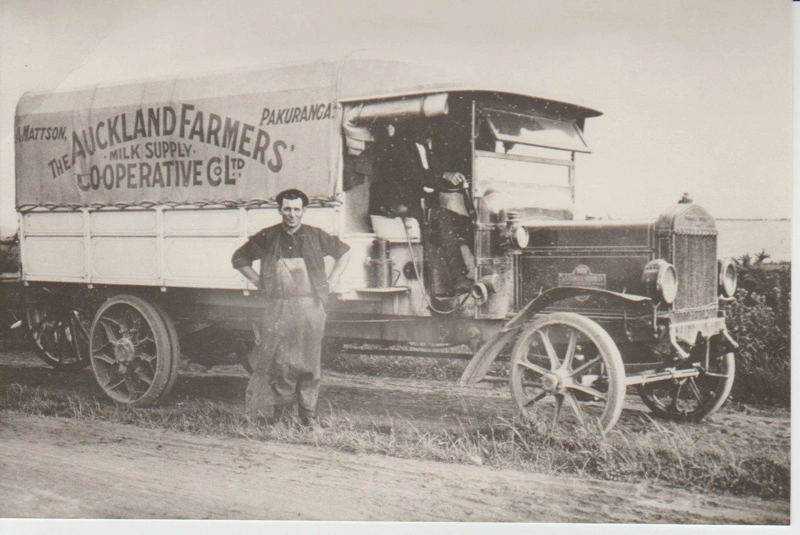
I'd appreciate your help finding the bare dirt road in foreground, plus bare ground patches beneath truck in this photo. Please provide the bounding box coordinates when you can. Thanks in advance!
[0,348,789,524]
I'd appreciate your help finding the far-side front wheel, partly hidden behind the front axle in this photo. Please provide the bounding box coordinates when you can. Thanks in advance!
[639,353,736,422]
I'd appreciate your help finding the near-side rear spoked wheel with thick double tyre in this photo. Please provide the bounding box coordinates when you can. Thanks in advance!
[90,295,180,406]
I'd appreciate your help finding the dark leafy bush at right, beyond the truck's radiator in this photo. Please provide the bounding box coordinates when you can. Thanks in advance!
[726,262,792,407]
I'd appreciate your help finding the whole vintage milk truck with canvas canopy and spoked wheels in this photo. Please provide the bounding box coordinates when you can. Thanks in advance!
[15,58,736,431]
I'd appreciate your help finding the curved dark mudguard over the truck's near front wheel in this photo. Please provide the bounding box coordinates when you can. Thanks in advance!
[459,286,651,385]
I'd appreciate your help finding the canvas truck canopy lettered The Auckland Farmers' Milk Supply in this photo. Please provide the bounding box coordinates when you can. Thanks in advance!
[15,59,599,211]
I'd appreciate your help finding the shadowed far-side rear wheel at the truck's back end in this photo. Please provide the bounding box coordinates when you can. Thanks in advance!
[25,289,92,372]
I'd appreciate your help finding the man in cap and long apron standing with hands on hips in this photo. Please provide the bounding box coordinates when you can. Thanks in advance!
[231,189,350,425]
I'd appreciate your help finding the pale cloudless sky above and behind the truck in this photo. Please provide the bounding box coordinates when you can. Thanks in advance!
[0,0,792,236]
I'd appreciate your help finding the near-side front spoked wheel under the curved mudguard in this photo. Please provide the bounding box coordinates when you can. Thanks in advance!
[510,312,625,432]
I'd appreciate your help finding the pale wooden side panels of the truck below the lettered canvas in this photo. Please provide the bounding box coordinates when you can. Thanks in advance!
[22,207,346,290]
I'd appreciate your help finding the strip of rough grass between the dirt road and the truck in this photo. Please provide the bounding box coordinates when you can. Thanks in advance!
[0,383,790,499]
